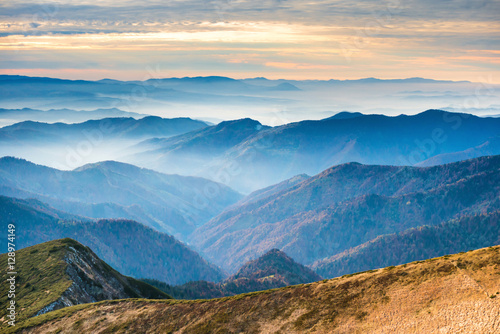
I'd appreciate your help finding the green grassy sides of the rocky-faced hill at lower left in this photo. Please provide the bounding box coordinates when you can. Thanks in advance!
[0,238,169,332]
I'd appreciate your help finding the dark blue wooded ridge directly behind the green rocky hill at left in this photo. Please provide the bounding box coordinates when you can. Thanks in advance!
[0,196,225,284]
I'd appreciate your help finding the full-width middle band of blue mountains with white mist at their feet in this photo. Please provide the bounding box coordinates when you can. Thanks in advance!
[0,110,500,194]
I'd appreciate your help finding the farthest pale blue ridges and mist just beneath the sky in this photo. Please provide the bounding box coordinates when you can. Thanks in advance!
[0,74,500,121]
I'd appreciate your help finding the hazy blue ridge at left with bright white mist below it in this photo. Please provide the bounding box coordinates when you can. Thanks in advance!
[0,116,207,170]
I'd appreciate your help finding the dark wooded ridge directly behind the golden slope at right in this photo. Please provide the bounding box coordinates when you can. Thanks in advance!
[311,211,500,277]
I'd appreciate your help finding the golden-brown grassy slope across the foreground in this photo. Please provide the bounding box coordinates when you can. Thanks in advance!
[10,246,500,334]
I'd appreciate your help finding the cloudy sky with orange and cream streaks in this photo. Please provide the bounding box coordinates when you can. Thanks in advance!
[0,0,500,83]
